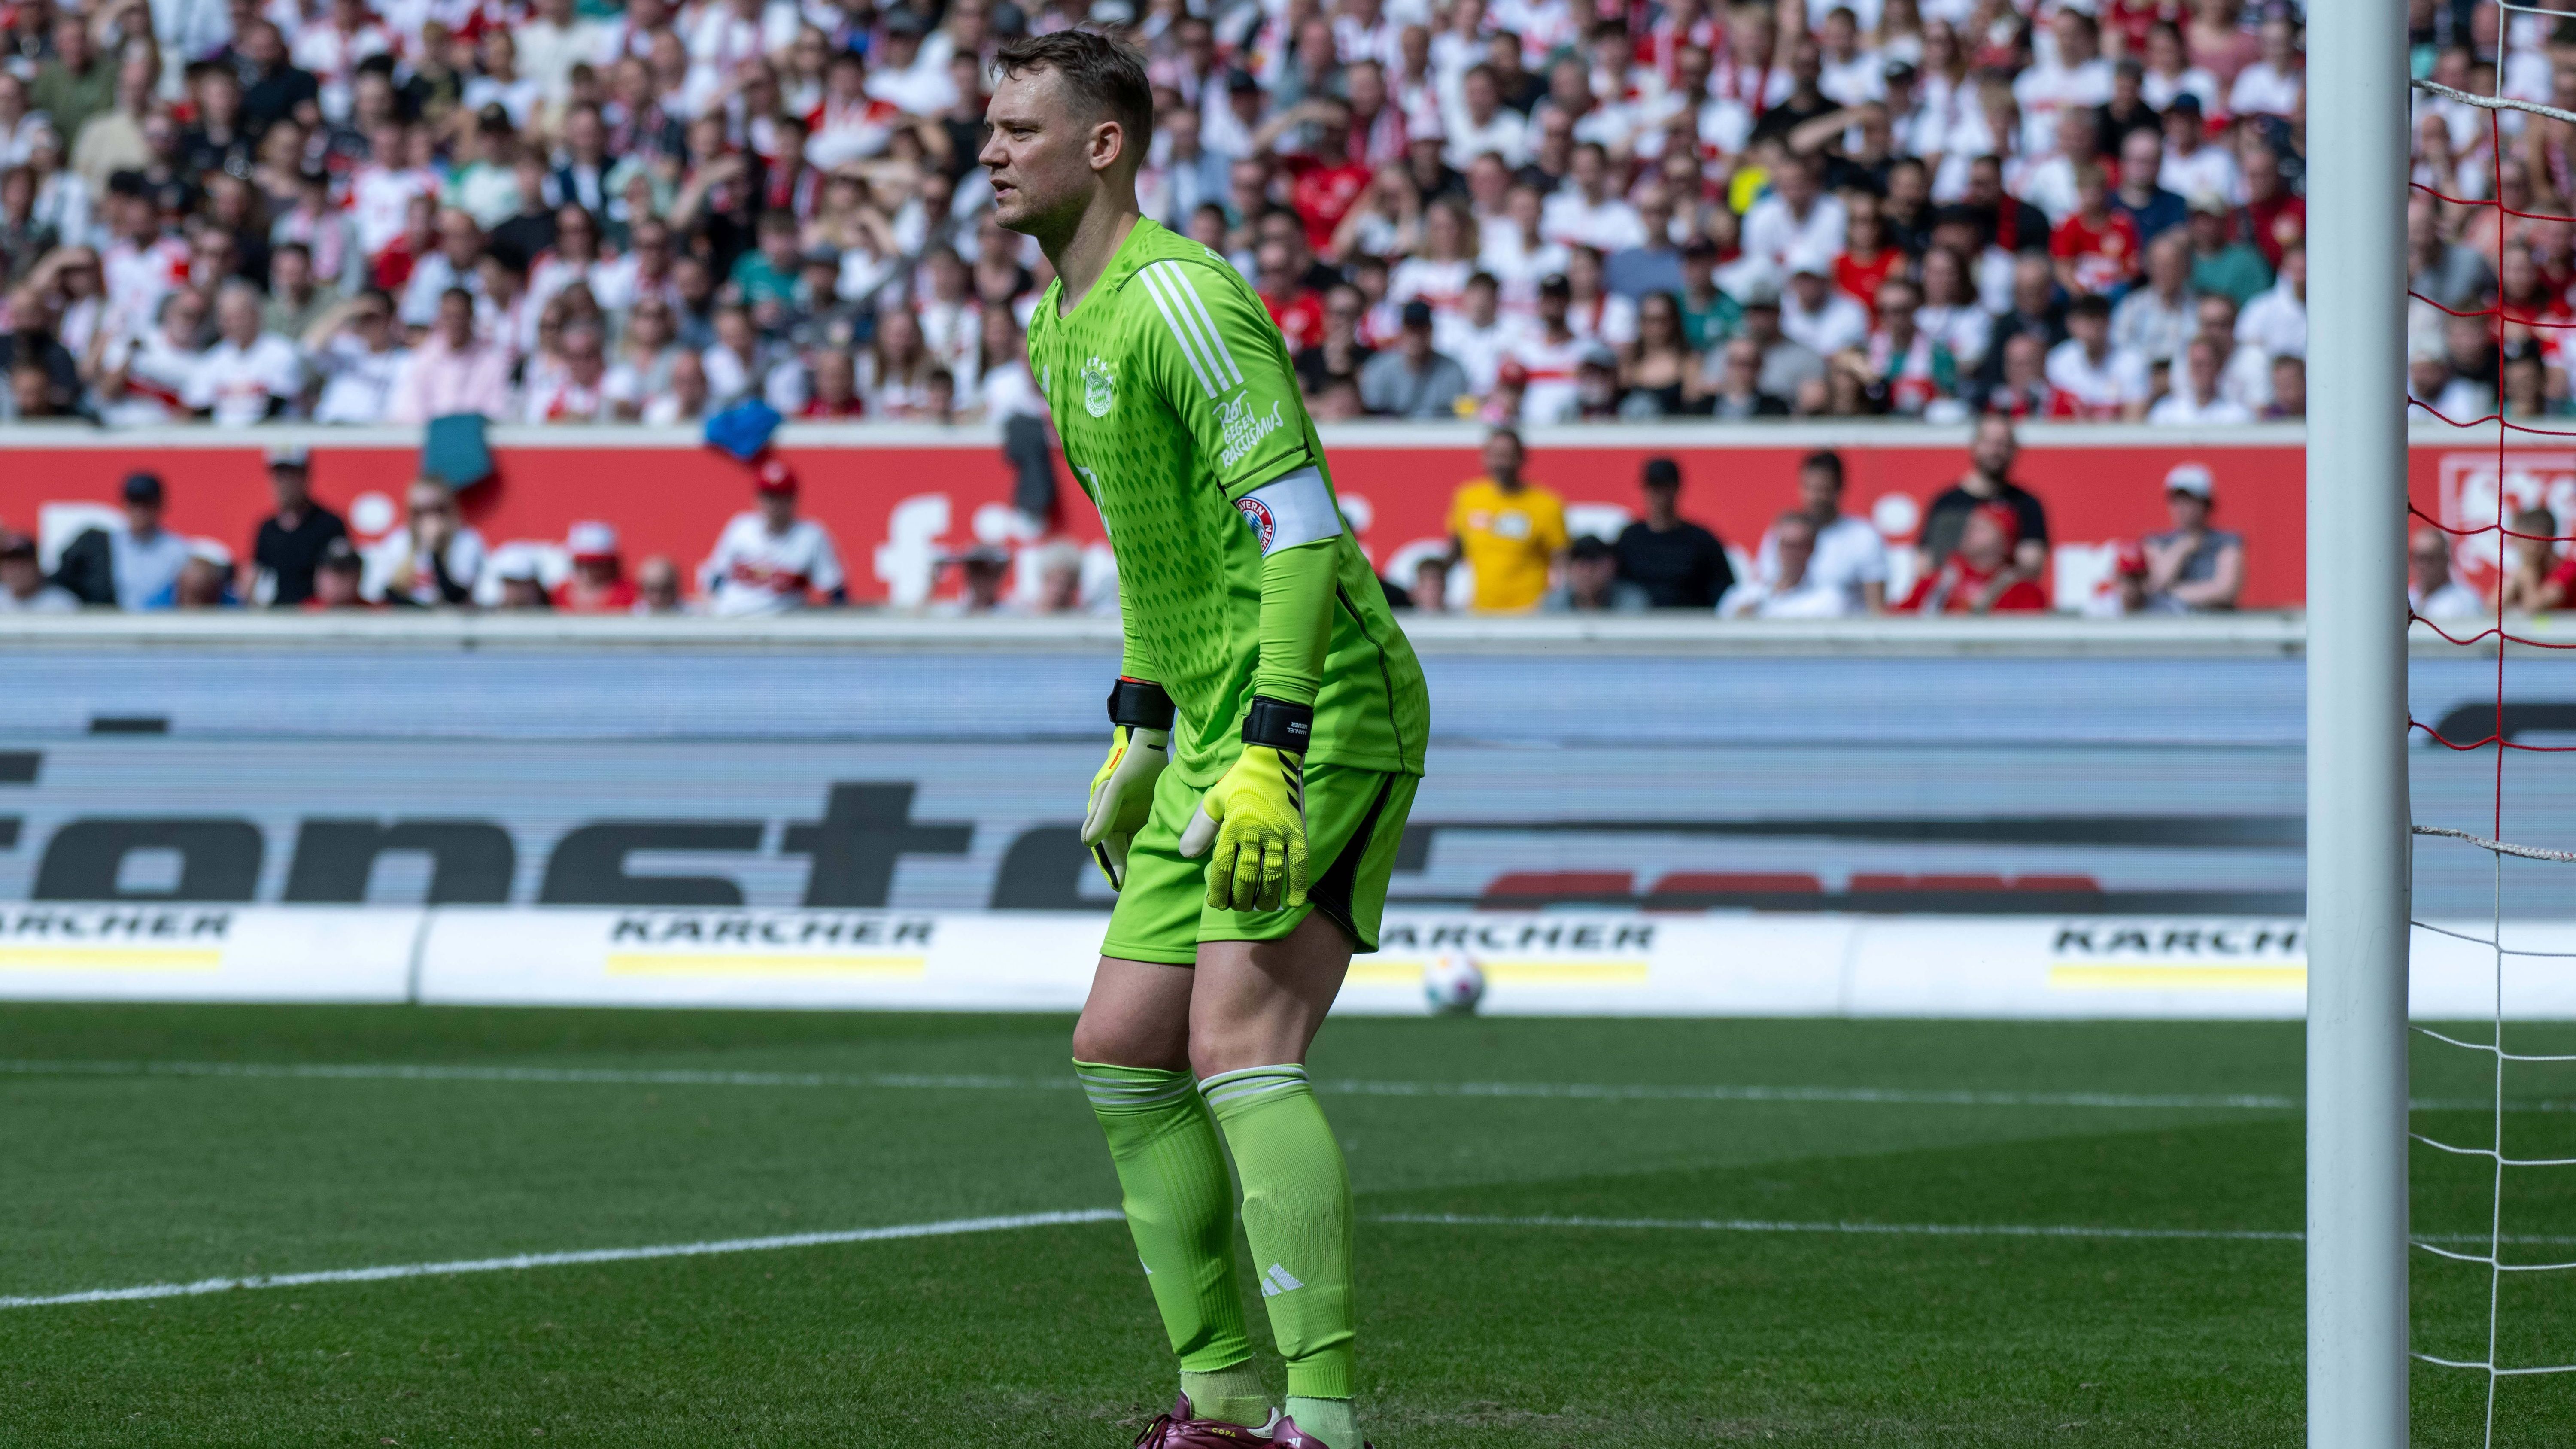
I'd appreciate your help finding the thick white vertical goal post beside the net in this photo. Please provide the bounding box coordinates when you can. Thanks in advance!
[2308,0,2411,1449]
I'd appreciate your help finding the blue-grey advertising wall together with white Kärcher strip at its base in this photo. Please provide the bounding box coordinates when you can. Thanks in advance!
[0,614,2576,1016]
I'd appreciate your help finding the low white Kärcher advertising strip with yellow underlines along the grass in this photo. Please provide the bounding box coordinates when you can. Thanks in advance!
[0,905,2576,1018]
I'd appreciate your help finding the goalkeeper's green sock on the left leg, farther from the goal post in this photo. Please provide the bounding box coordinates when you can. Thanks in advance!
[1074,1062,1270,1426]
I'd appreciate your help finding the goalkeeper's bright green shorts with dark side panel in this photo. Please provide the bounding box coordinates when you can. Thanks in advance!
[1100,747,1422,967]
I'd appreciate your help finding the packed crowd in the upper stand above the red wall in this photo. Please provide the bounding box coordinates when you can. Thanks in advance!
[0,0,2318,428]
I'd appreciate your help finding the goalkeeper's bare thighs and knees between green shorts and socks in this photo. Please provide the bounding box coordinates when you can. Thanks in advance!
[1074,913,1350,1078]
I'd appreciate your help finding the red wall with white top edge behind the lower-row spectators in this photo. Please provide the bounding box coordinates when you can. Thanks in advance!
[0,423,2524,608]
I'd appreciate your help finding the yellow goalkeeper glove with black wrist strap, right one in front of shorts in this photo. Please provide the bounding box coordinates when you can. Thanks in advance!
[1180,693,1314,910]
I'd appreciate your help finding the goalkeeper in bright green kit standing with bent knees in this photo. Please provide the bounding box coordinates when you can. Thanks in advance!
[979,31,1430,1449]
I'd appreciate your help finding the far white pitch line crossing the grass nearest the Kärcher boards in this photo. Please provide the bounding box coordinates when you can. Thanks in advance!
[0,1060,2339,1111]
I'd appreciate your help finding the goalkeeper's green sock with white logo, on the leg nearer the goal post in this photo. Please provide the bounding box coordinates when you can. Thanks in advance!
[1198,1062,1360,1413]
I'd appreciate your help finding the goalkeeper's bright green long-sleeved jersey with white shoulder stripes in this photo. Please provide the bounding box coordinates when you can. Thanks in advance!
[1028,219,1430,787]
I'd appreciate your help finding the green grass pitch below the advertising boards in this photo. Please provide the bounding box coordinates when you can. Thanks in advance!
[0,1005,2576,1449]
